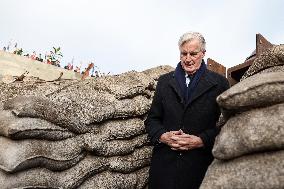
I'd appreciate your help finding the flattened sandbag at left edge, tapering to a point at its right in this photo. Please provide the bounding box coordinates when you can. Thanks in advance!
[0,111,75,140]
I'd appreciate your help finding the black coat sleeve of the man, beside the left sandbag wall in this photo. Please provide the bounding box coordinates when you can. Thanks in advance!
[144,79,167,145]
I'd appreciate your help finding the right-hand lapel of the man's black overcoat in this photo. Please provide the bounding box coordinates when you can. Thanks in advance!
[186,70,217,107]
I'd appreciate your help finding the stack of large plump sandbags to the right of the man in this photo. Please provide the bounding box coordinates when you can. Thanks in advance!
[200,45,284,189]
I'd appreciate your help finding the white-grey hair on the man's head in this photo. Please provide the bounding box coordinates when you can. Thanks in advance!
[178,32,206,51]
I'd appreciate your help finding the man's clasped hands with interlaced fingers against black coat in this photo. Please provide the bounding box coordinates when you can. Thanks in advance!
[160,130,203,150]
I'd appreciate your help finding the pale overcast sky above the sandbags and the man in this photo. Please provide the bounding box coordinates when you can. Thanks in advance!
[0,0,284,74]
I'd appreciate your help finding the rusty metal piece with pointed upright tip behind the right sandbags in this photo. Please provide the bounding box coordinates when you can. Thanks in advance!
[227,34,273,86]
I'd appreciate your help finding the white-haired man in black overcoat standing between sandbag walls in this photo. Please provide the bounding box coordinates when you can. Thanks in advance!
[145,32,229,189]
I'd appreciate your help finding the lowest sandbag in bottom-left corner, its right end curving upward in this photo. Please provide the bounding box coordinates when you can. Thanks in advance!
[0,156,108,189]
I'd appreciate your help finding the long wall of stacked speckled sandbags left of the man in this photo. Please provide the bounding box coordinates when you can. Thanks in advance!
[0,66,172,189]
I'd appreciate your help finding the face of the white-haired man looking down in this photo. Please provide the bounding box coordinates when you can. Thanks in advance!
[180,40,205,75]
